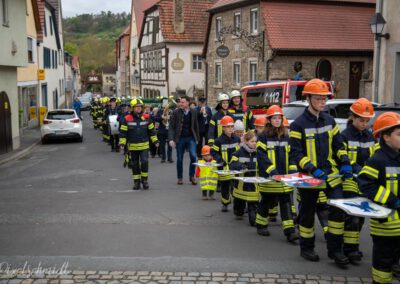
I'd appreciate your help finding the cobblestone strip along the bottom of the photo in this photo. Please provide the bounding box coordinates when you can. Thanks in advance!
[0,270,399,284]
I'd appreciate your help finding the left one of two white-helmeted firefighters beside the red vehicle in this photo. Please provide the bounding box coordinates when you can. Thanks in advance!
[208,93,229,146]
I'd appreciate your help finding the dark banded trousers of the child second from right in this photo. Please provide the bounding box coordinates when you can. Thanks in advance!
[343,191,365,253]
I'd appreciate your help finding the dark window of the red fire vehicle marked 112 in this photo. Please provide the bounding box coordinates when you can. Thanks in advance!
[246,86,283,109]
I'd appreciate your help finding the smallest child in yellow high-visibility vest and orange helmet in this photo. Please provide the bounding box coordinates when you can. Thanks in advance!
[196,145,218,200]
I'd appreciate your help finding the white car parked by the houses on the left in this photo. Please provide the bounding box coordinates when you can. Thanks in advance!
[40,109,83,144]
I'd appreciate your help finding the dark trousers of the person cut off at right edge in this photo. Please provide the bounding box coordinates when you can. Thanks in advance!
[372,236,400,283]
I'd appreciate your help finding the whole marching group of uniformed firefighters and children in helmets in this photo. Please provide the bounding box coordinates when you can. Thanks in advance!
[87,79,400,283]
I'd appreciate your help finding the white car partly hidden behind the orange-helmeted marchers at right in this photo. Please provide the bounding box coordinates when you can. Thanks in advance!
[282,99,378,131]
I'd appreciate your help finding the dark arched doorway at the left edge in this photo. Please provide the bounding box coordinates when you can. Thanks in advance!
[0,92,12,154]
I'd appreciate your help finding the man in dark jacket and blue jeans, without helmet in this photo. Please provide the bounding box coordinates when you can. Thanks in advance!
[168,96,199,185]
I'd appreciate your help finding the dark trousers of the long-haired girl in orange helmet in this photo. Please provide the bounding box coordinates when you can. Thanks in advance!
[256,192,295,236]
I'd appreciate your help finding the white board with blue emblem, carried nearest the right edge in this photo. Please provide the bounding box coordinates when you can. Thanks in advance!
[328,197,393,219]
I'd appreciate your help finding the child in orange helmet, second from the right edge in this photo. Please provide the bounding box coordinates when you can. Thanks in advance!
[341,98,375,263]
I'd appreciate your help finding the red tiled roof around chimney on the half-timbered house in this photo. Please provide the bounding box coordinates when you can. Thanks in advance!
[157,0,215,43]
